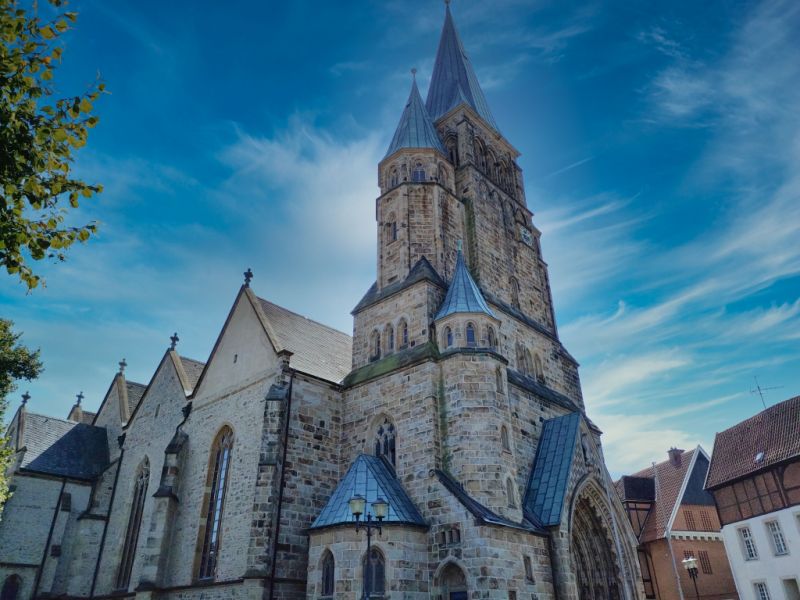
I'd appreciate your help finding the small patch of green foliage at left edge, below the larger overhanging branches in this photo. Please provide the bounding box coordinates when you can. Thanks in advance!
[0,319,42,511]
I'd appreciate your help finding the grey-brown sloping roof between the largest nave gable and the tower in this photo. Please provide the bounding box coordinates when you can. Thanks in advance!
[259,298,353,383]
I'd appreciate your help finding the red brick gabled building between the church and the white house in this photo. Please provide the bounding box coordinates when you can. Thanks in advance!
[616,446,739,600]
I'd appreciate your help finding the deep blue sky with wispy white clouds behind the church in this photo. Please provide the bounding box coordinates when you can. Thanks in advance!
[0,0,800,474]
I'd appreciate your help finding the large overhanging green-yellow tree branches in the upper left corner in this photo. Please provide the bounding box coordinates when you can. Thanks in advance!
[0,0,104,289]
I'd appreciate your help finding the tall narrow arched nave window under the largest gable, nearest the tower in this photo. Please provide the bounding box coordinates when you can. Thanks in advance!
[197,426,233,579]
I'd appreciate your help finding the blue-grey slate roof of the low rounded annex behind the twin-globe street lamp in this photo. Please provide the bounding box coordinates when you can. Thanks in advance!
[310,454,428,529]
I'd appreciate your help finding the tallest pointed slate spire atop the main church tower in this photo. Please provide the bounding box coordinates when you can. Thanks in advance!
[425,5,499,131]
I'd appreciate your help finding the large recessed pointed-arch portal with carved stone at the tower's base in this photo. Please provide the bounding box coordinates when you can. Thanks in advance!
[570,496,620,600]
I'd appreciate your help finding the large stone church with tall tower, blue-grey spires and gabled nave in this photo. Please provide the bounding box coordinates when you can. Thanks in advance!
[0,7,642,600]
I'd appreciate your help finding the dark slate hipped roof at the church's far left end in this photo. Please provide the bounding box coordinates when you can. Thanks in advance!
[20,412,109,480]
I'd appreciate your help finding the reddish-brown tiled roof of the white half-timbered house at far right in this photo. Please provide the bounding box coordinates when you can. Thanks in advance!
[706,396,800,489]
